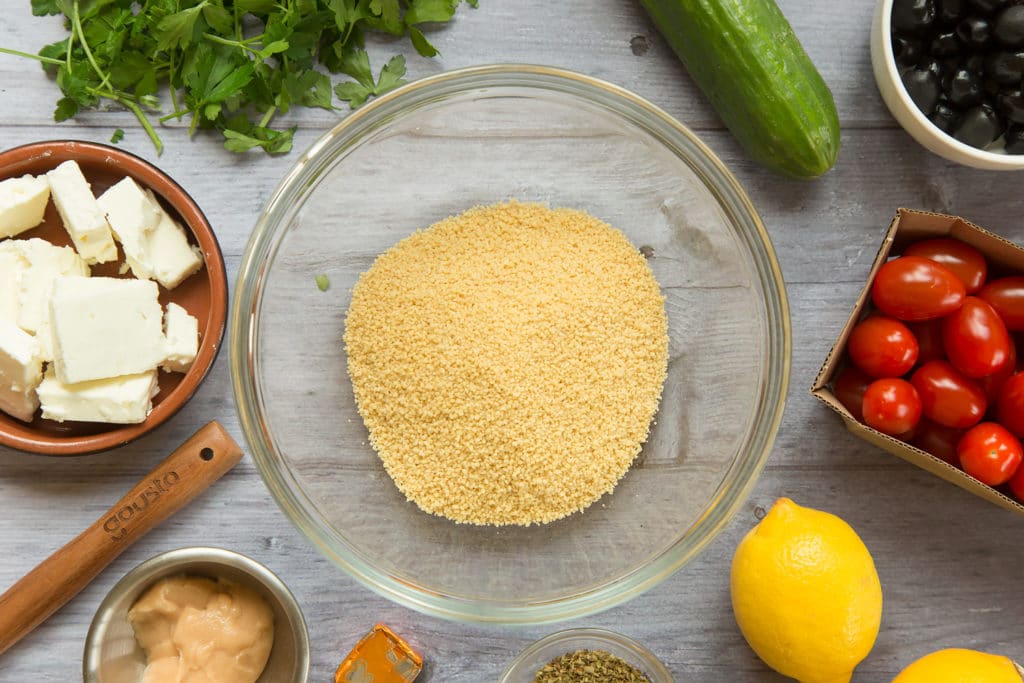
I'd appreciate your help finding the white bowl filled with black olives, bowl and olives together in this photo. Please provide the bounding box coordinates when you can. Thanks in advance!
[871,0,1024,170]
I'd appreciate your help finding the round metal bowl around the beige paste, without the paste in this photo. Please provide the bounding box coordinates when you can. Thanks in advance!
[82,547,309,683]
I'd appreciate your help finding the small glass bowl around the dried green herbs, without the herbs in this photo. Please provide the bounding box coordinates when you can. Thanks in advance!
[499,629,675,683]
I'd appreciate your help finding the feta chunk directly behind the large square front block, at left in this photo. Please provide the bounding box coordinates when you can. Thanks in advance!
[0,238,89,337]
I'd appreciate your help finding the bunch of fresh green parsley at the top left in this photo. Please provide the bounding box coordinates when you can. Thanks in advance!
[0,0,477,154]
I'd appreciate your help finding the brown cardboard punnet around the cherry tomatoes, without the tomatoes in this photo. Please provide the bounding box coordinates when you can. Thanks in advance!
[811,209,1024,515]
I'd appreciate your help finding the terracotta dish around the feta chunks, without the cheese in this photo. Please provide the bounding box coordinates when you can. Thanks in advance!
[0,140,227,456]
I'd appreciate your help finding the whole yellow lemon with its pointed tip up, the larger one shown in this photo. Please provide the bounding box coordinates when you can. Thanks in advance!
[731,498,882,683]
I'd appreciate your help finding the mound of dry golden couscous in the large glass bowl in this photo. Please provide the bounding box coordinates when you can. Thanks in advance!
[345,202,668,525]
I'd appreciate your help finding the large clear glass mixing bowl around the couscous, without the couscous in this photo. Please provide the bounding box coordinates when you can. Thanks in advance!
[230,66,791,624]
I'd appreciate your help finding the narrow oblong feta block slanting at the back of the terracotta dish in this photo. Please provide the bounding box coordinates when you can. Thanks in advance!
[46,161,118,264]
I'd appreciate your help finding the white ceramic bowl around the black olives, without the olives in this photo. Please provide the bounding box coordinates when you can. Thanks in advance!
[871,0,1024,171]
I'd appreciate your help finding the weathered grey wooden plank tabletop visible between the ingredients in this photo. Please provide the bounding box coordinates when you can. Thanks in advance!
[0,0,1024,683]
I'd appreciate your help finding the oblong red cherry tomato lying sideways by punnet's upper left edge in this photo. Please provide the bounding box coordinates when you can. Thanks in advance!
[871,256,967,321]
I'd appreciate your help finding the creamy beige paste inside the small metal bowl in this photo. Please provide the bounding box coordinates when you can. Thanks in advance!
[128,575,273,683]
